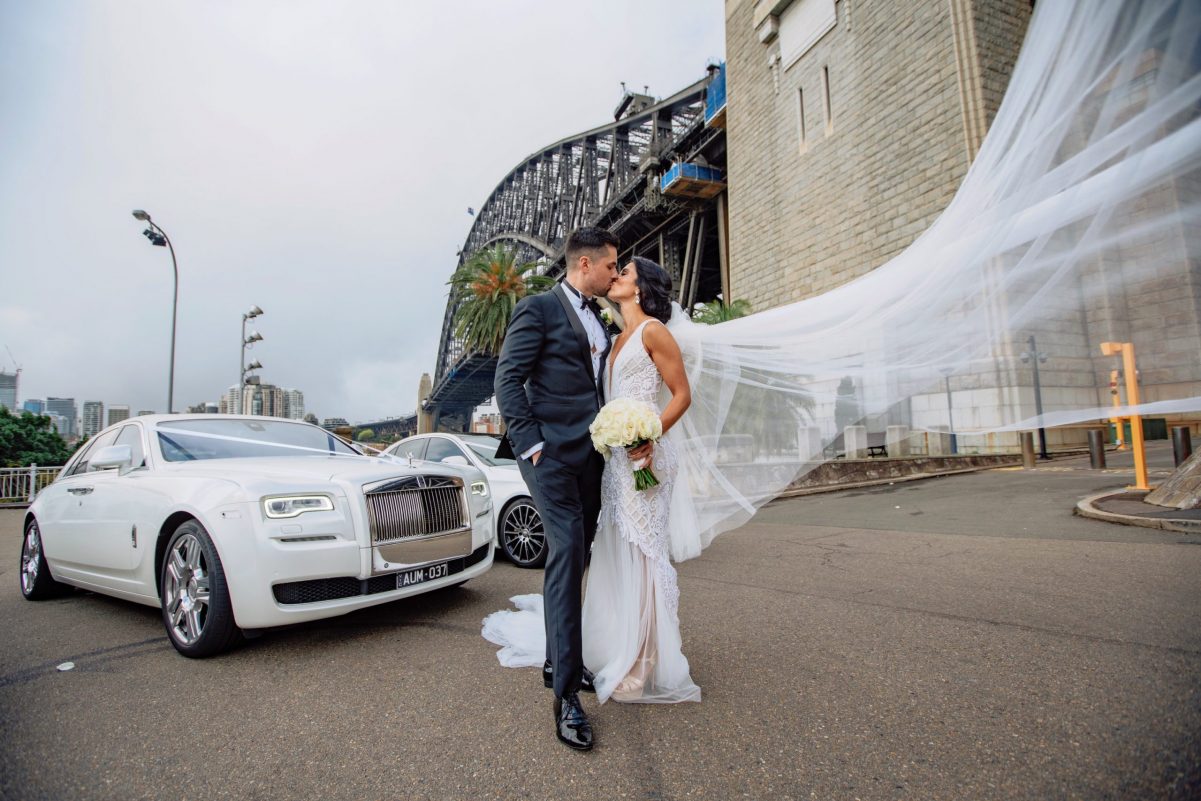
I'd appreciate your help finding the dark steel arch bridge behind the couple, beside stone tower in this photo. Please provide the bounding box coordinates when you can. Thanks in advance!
[424,66,729,430]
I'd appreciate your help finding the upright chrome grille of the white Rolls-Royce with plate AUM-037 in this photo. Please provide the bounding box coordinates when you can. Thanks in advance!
[364,477,470,544]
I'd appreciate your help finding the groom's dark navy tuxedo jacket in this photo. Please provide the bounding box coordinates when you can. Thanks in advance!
[494,283,611,466]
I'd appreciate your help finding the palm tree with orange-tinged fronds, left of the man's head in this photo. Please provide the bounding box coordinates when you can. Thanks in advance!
[448,244,555,355]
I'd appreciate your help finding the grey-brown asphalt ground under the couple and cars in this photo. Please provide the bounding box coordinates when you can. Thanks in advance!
[0,459,1201,800]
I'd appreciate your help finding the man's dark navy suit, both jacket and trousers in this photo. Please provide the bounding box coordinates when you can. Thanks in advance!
[495,285,609,698]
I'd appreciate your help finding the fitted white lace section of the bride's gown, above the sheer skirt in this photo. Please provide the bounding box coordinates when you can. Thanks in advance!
[601,319,680,615]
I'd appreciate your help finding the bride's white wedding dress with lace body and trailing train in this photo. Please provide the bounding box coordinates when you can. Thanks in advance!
[483,321,700,704]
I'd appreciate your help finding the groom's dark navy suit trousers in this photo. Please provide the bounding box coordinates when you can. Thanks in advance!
[518,452,604,698]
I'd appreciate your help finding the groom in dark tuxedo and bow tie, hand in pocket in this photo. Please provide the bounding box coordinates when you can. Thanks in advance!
[495,228,617,751]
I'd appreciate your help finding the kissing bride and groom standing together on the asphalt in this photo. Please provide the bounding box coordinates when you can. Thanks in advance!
[483,228,700,751]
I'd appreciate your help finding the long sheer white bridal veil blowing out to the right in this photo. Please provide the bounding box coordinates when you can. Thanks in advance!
[670,0,1201,560]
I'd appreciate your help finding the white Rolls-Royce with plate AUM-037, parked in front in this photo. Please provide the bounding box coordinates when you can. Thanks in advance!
[20,414,492,657]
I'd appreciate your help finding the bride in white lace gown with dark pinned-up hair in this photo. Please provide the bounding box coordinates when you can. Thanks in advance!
[483,256,700,704]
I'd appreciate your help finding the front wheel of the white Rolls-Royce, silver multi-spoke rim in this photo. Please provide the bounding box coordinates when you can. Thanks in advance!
[161,520,241,658]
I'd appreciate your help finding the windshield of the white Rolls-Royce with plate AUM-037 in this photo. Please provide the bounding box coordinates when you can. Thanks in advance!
[157,419,358,461]
